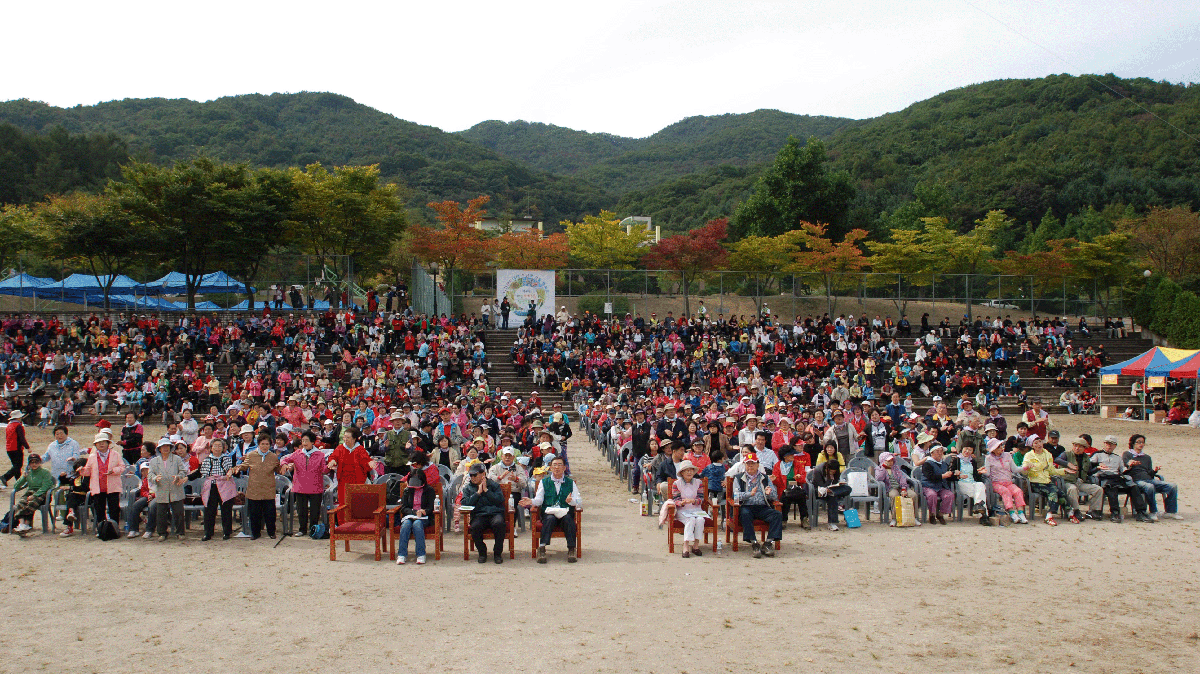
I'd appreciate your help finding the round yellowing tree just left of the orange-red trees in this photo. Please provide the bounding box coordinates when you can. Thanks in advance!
[292,163,408,276]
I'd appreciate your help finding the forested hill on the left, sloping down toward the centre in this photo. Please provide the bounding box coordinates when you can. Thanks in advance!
[0,94,608,223]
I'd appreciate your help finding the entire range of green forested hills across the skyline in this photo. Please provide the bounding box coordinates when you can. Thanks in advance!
[0,76,1200,235]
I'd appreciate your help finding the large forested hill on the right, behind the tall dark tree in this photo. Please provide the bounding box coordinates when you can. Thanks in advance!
[617,76,1200,235]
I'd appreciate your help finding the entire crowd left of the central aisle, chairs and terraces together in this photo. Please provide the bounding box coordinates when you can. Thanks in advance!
[0,304,582,562]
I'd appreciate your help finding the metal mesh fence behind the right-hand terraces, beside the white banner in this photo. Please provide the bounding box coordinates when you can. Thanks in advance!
[441,269,1128,323]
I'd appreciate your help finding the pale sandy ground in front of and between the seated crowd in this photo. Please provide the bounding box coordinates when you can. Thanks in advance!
[0,417,1200,673]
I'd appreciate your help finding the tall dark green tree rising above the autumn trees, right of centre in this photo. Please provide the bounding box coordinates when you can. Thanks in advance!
[732,137,854,240]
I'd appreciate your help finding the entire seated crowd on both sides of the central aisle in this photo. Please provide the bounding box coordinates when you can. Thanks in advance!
[0,309,1177,564]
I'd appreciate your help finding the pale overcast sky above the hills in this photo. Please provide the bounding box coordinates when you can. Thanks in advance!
[0,0,1200,137]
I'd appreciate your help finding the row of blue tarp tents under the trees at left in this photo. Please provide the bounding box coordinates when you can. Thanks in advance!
[0,271,257,312]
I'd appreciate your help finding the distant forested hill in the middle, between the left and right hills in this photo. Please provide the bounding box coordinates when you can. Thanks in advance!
[460,110,852,194]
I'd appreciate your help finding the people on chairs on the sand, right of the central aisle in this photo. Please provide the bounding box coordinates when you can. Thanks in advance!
[578,387,1182,556]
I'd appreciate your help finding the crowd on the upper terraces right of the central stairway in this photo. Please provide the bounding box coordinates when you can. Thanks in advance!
[510,312,1104,413]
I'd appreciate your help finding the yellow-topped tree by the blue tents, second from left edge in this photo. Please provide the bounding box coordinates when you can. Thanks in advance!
[36,193,144,309]
